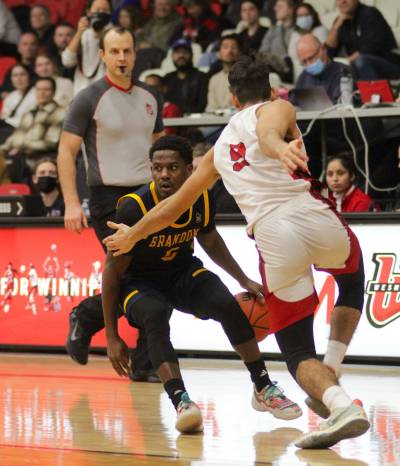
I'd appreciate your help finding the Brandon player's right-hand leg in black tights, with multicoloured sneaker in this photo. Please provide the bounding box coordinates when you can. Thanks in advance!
[176,268,302,419]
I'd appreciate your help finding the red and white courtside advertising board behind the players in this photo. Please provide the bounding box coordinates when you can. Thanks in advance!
[0,224,400,357]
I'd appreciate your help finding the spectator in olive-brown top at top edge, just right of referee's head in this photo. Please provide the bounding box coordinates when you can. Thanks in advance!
[137,0,183,52]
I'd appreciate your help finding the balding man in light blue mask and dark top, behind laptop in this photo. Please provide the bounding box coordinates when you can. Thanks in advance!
[293,34,350,105]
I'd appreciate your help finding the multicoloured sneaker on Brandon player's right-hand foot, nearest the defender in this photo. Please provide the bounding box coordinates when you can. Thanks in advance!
[251,382,303,420]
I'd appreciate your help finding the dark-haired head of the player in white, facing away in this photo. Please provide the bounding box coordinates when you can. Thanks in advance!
[228,55,271,104]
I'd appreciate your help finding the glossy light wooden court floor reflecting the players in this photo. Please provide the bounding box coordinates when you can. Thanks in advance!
[0,353,400,466]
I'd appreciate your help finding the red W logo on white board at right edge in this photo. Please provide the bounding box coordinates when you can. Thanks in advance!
[366,253,400,328]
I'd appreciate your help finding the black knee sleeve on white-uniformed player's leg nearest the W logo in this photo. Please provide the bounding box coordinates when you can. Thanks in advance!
[335,257,365,313]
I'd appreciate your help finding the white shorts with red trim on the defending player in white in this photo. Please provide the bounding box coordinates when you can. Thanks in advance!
[253,193,361,333]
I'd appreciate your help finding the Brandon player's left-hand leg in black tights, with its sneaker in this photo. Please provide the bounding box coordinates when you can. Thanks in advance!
[125,291,203,432]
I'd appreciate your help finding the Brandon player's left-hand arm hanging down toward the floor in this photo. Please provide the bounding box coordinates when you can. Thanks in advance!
[101,253,132,377]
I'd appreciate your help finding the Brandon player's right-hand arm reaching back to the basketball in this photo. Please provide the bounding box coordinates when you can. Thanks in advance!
[197,228,264,304]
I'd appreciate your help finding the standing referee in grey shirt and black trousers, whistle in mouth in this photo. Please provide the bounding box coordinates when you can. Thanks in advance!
[58,27,164,382]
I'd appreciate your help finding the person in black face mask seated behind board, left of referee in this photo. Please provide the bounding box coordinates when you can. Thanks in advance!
[32,157,65,217]
